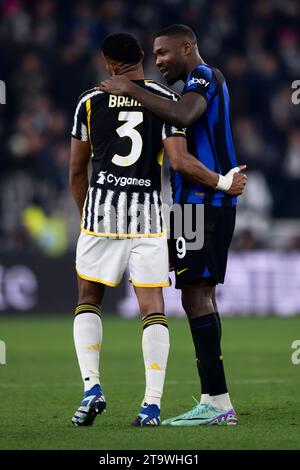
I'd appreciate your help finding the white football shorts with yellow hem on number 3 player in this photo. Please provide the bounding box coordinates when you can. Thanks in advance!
[76,231,169,287]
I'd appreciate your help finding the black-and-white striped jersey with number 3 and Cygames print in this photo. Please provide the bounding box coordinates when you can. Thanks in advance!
[72,80,185,237]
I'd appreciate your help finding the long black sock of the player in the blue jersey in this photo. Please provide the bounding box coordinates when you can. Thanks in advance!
[189,313,228,395]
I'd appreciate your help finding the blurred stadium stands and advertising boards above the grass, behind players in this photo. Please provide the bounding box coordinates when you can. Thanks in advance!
[0,0,300,316]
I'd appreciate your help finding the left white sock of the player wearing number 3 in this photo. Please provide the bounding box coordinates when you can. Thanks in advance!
[73,307,102,392]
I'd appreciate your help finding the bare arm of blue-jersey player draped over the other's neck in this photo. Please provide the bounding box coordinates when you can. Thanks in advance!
[99,75,207,127]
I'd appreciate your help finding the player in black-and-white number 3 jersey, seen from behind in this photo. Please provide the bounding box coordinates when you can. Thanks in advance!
[70,33,243,426]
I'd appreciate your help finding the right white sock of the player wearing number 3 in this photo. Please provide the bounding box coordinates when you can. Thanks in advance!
[142,324,170,408]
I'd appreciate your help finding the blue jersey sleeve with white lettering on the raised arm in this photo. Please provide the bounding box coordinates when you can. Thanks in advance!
[182,66,217,104]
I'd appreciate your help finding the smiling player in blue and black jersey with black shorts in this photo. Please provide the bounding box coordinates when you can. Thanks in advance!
[100,25,246,426]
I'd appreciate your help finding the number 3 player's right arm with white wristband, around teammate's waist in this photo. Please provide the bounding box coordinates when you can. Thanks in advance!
[163,136,247,196]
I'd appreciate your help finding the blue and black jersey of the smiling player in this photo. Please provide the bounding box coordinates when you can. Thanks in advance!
[171,64,237,206]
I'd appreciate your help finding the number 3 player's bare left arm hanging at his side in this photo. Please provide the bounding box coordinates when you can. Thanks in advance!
[69,137,91,216]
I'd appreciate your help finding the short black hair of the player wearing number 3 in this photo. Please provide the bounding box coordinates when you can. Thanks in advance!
[101,33,142,64]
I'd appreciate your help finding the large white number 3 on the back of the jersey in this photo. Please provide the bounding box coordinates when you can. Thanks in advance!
[112,111,143,166]
